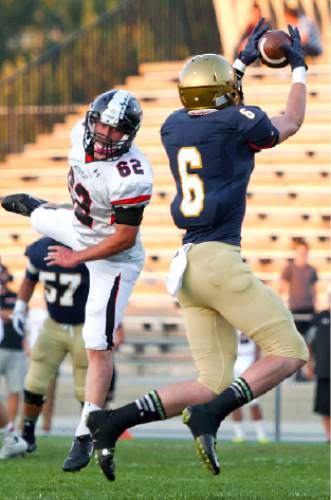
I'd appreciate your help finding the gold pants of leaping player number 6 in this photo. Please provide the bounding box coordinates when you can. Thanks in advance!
[178,242,308,394]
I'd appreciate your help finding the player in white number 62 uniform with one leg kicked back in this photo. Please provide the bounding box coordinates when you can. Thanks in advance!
[2,90,153,472]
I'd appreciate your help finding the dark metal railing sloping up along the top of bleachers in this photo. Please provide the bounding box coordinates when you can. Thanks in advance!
[0,0,220,161]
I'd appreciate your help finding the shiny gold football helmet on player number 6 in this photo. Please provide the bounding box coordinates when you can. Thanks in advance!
[178,54,241,110]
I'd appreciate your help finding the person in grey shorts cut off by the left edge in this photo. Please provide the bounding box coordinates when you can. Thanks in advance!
[0,264,26,432]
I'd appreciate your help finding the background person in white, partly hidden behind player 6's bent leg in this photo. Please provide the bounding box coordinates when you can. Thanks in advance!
[232,332,268,443]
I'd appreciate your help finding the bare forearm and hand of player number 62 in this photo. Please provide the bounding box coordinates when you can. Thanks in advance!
[45,224,139,267]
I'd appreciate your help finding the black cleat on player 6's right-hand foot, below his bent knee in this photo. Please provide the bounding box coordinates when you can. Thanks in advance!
[183,405,221,475]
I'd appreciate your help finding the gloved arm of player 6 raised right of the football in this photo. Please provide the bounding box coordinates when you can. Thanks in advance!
[271,25,307,143]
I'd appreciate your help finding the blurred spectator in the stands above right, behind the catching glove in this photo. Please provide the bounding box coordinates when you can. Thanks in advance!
[285,0,323,57]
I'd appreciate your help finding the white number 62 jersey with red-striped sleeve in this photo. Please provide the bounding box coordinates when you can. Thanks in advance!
[68,120,153,262]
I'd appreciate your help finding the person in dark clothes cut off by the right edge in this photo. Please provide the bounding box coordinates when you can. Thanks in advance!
[305,296,331,442]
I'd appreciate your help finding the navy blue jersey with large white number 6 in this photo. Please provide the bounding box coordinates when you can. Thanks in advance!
[161,105,279,245]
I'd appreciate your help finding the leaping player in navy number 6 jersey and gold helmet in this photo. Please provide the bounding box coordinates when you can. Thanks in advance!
[87,19,308,479]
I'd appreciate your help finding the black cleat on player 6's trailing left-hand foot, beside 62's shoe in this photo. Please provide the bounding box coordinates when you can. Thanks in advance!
[86,410,123,481]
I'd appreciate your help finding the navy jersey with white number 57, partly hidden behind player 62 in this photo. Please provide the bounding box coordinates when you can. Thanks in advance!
[25,238,89,325]
